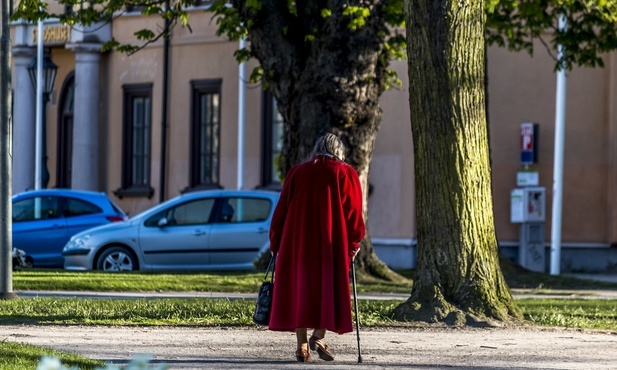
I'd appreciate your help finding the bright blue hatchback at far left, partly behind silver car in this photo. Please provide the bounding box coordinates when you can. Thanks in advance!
[13,189,128,267]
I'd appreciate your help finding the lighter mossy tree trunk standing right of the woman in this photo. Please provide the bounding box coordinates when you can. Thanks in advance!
[395,0,521,324]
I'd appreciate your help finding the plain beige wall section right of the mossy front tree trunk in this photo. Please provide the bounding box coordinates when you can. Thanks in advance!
[488,44,614,243]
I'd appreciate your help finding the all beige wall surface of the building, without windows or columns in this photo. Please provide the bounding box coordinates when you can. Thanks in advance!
[10,9,617,250]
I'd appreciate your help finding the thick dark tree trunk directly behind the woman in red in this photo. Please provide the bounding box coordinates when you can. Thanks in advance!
[234,0,396,279]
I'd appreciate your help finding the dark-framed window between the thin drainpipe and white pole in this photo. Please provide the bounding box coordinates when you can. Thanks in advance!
[189,80,221,190]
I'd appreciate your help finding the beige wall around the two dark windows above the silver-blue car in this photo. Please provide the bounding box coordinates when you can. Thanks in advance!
[107,11,262,214]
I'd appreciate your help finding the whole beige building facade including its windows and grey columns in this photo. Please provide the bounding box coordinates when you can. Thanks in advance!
[11,7,617,267]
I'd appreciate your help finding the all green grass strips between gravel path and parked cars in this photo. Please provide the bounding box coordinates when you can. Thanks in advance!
[6,261,617,330]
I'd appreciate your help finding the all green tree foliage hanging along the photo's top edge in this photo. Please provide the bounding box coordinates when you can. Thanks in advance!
[13,0,617,71]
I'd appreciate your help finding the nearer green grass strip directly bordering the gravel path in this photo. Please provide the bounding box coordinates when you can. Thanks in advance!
[0,297,617,330]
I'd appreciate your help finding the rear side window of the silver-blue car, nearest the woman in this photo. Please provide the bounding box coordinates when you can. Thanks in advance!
[217,198,272,222]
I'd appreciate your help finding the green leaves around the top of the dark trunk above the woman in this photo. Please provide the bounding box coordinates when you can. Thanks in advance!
[209,0,405,92]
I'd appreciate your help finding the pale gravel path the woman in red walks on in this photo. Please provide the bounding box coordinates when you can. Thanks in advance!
[0,325,617,370]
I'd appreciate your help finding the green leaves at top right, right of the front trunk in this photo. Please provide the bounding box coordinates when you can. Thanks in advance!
[487,0,617,69]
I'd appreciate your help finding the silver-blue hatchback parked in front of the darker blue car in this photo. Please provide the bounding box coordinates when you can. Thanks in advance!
[62,190,279,271]
